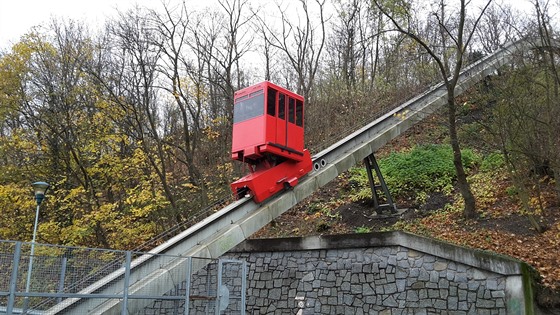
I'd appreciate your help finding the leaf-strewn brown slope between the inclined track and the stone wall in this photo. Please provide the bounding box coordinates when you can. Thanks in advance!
[253,112,560,308]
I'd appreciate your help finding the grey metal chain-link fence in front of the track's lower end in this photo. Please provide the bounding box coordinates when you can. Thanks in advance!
[0,241,247,314]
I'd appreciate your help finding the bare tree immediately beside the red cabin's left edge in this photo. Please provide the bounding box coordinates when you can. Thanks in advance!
[189,0,254,164]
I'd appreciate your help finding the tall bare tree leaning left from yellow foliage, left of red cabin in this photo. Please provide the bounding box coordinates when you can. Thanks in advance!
[92,7,177,214]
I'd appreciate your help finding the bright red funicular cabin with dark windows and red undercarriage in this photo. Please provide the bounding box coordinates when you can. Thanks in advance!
[231,81,312,202]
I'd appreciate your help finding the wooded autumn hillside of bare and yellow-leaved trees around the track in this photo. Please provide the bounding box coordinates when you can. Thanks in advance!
[0,0,560,304]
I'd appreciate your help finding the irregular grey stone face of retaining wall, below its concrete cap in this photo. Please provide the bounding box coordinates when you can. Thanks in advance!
[229,246,506,315]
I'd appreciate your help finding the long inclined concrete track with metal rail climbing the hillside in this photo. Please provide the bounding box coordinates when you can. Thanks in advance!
[50,40,532,314]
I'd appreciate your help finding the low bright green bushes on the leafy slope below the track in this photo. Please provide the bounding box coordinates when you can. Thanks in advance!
[352,145,480,199]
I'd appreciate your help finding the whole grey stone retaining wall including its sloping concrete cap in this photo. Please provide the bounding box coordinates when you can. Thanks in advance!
[227,232,533,315]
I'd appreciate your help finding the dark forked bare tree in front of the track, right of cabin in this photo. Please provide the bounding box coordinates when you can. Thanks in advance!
[374,0,491,218]
